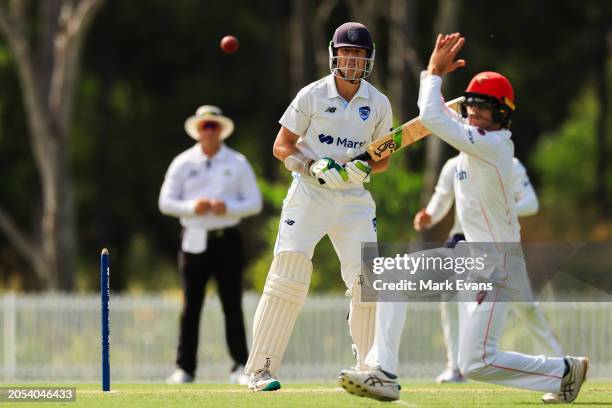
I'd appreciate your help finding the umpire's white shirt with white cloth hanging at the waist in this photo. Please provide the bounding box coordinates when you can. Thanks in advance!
[159,144,262,253]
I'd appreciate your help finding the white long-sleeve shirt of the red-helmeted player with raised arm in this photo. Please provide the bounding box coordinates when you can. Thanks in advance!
[419,72,521,242]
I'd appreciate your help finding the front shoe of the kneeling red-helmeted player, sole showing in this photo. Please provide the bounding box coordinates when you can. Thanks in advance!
[338,368,400,401]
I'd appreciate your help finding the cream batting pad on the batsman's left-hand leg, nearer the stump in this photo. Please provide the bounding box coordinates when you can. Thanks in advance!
[244,252,312,374]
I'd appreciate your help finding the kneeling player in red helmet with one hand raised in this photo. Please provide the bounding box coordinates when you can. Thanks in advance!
[339,33,588,403]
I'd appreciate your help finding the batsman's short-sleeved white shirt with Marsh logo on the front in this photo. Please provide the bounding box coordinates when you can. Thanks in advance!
[279,74,393,188]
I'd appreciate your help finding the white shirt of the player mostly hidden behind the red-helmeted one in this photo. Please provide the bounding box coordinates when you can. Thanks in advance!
[425,156,539,236]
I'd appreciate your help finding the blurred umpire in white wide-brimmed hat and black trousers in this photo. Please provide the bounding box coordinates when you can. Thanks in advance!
[159,105,262,384]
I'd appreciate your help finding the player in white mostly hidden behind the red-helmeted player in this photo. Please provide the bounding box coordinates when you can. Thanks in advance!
[414,156,563,384]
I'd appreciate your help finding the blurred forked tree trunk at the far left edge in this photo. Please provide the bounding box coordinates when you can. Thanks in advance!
[0,0,102,290]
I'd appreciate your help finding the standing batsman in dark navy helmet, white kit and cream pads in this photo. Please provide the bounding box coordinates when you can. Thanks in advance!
[245,22,392,391]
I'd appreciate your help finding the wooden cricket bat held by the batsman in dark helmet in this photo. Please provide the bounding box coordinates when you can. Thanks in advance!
[351,97,463,161]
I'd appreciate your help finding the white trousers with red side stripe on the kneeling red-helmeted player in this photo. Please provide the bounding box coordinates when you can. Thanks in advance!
[365,249,565,393]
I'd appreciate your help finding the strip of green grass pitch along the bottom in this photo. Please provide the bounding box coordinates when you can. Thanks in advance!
[2,381,612,408]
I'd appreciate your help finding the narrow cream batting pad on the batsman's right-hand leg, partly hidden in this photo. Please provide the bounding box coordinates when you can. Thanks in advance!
[348,279,376,369]
